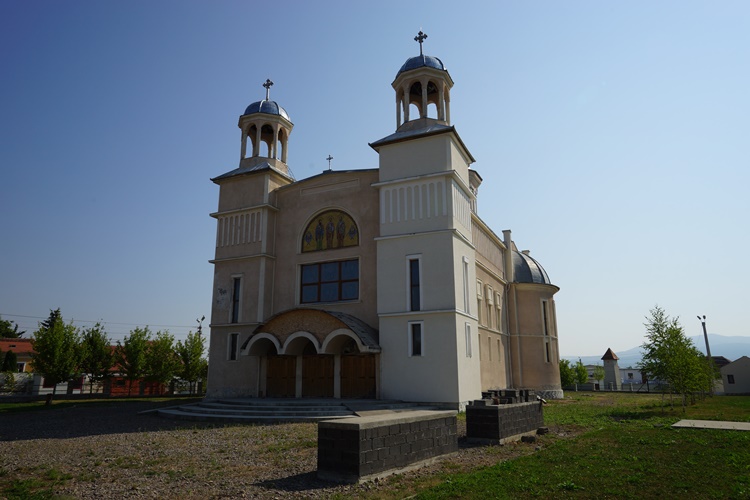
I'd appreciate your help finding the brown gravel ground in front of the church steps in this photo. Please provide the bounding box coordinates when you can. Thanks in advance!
[0,401,560,499]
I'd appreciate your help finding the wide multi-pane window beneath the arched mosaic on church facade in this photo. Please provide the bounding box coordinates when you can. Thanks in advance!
[300,259,359,304]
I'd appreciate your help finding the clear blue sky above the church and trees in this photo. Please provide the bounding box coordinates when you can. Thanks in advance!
[0,0,750,355]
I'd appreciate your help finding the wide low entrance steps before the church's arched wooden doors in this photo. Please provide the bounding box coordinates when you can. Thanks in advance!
[156,398,436,424]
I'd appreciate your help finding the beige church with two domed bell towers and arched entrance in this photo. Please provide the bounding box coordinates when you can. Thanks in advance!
[207,31,562,408]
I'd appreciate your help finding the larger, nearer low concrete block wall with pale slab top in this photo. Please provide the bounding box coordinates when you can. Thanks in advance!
[318,411,458,483]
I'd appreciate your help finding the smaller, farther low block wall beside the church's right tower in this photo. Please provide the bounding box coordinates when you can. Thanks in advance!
[466,400,544,442]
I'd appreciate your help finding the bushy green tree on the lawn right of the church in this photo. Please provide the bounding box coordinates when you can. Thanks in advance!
[639,306,715,411]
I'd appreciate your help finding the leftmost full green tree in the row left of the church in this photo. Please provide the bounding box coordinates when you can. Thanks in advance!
[31,308,79,405]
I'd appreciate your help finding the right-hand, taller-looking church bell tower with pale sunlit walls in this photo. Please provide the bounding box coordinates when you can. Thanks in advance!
[370,31,481,408]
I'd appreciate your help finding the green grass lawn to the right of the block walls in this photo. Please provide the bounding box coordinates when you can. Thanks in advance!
[417,393,750,498]
